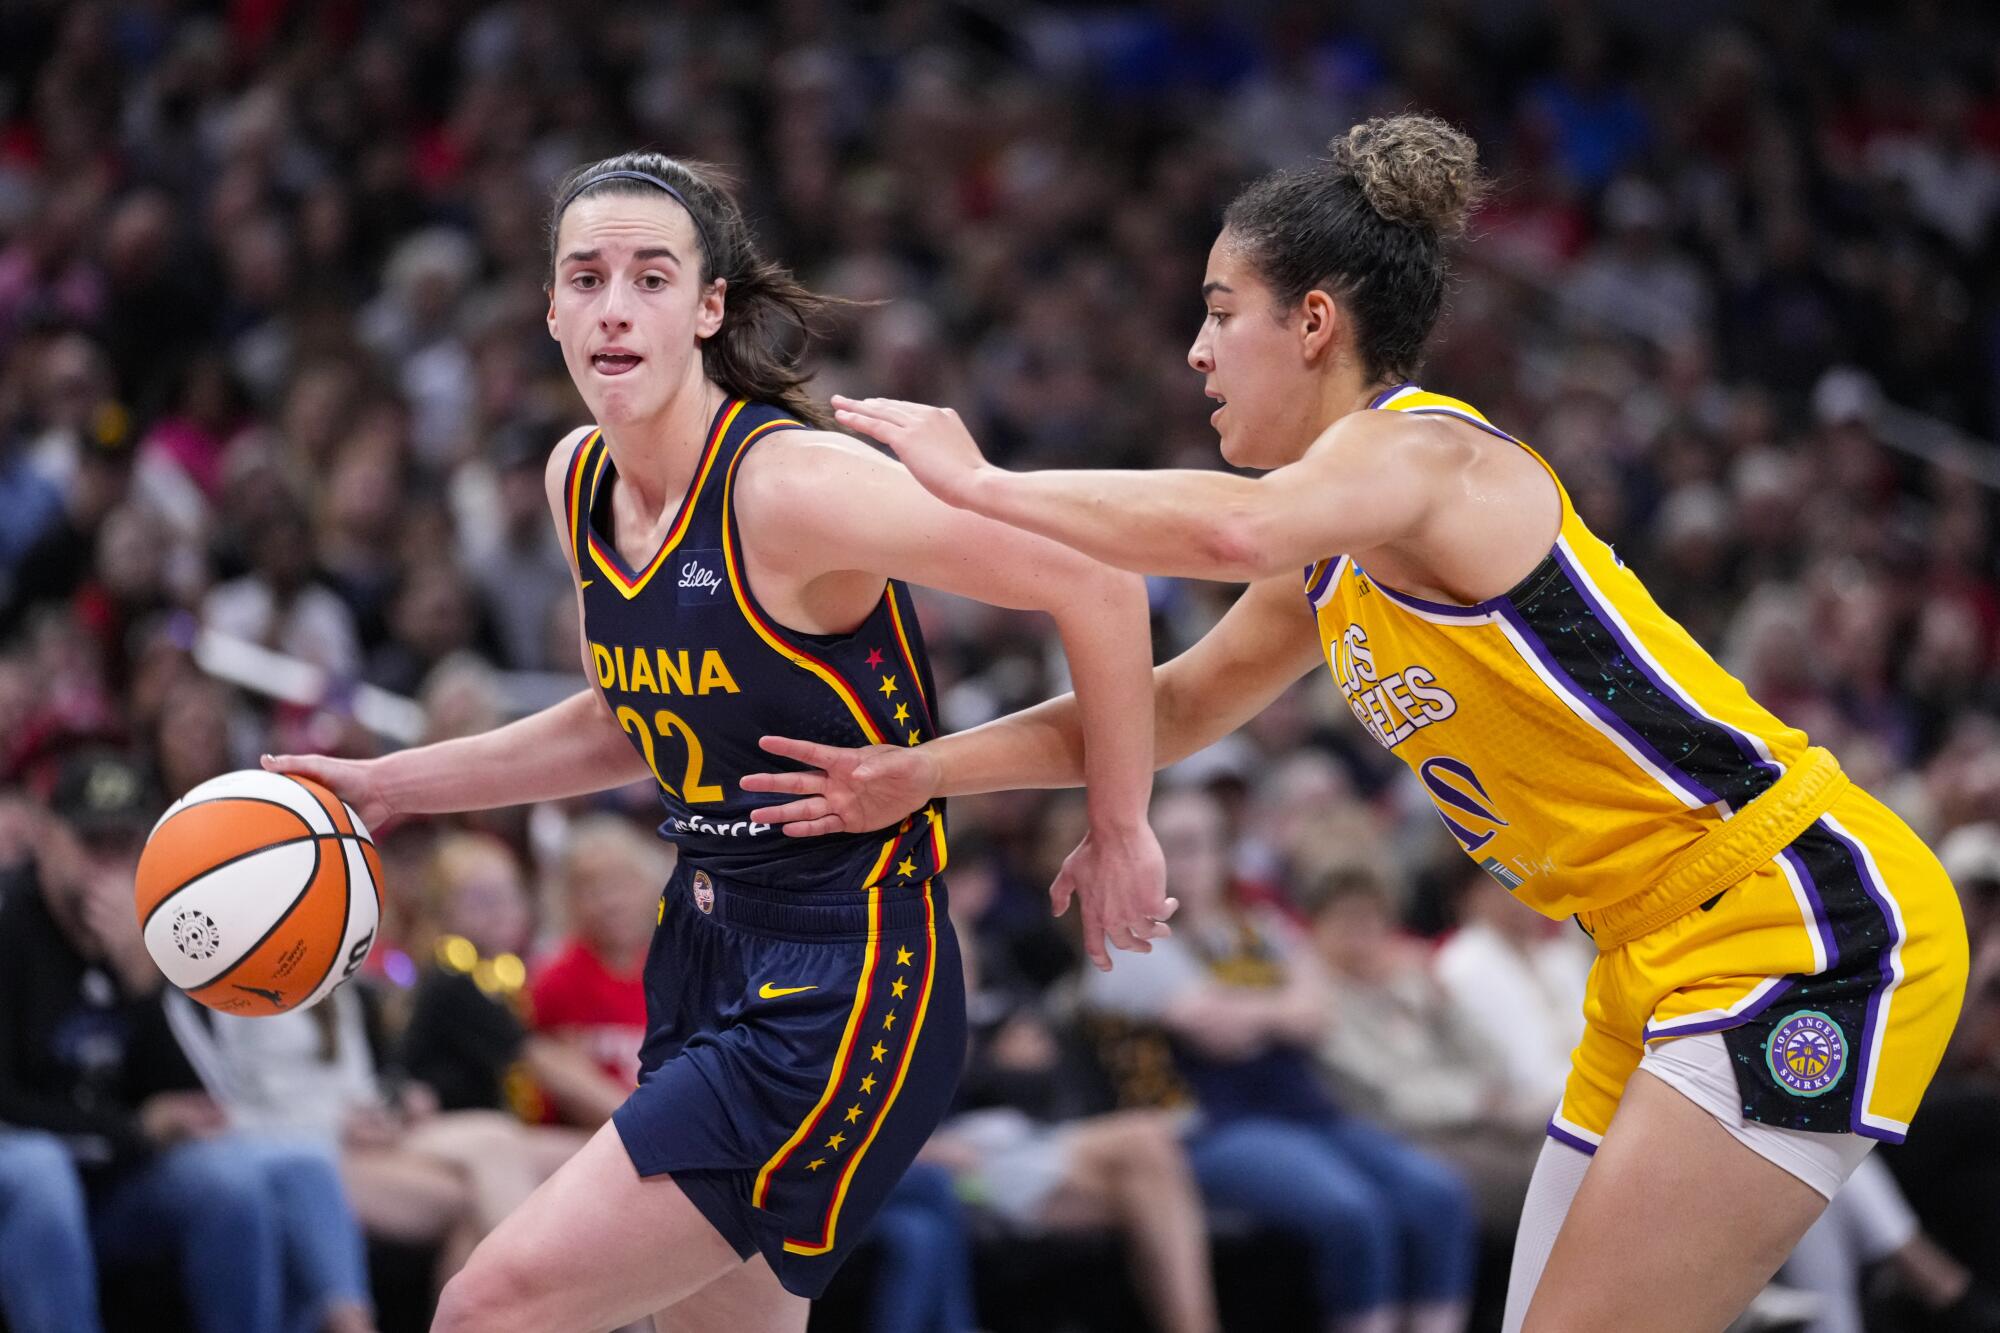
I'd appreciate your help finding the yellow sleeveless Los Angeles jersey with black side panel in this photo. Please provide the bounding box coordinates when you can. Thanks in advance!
[1306,384,1824,917]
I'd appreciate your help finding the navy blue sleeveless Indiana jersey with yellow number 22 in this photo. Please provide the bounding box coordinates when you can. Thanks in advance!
[564,398,946,891]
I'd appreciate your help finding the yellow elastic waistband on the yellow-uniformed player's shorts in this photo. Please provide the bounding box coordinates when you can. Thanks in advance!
[1576,745,1848,953]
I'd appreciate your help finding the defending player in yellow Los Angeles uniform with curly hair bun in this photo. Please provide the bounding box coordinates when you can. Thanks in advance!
[750,116,1966,1333]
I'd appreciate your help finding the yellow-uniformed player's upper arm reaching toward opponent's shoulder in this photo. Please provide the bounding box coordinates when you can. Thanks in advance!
[834,398,1462,582]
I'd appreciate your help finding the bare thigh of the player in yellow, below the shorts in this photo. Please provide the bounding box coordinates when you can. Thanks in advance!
[1524,1071,1826,1333]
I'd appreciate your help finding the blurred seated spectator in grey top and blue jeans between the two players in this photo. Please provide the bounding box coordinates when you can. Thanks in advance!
[1084,791,1478,1333]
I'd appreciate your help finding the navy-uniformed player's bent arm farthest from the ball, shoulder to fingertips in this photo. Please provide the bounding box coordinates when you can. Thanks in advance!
[734,430,1172,967]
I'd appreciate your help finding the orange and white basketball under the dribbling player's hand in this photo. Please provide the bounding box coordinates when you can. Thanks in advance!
[134,769,382,1017]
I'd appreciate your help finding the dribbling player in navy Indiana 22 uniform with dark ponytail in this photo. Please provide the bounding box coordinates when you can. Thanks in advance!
[266,154,1172,1333]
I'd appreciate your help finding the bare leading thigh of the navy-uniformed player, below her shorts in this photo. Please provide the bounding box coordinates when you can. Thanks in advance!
[446,1125,742,1329]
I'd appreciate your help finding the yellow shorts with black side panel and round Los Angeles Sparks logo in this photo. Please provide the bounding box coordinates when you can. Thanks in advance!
[1548,787,1966,1153]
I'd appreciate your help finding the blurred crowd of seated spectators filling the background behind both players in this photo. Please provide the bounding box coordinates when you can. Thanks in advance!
[0,0,2000,1333]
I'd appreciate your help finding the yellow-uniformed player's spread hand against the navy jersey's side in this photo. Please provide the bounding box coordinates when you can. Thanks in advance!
[742,737,938,839]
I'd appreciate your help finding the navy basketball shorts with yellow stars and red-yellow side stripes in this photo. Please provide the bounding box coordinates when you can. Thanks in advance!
[612,863,966,1299]
